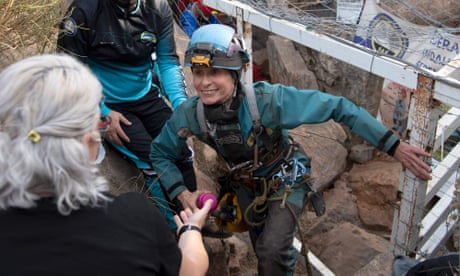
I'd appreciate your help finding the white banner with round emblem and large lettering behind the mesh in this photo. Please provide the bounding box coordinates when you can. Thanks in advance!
[354,0,460,71]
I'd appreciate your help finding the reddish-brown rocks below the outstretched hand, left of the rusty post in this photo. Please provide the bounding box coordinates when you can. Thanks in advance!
[300,155,400,275]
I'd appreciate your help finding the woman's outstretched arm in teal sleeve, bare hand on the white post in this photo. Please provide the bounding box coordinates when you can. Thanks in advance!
[255,83,431,180]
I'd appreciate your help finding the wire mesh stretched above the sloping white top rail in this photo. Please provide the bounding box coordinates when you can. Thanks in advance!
[241,0,460,70]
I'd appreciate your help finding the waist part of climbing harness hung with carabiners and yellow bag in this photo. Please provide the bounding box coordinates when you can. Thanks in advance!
[216,158,326,232]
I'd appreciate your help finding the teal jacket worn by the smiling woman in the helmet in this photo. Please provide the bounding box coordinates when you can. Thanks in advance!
[150,82,399,198]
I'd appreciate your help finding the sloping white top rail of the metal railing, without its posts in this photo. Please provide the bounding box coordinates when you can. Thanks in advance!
[204,0,460,108]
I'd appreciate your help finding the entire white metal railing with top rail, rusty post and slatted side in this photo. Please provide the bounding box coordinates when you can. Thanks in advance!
[204,0,460,275]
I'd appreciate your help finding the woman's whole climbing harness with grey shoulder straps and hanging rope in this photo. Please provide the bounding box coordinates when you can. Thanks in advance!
[197,84,326,271]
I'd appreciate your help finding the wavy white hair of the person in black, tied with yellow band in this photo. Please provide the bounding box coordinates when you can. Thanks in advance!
[0,54,108,214]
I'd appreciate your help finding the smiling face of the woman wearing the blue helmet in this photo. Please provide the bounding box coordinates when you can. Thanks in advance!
[192,67,235,105]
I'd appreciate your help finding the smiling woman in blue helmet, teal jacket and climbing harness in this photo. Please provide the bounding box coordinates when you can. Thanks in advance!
[150,24,431,276]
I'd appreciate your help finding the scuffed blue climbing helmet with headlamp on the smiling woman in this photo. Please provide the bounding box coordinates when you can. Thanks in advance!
[184,24,249,71]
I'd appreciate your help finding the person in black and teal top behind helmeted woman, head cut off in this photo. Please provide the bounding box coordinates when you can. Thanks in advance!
[57,0,196,230]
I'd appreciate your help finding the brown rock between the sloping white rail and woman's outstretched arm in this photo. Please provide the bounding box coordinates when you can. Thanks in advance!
[266,35,383,115]
